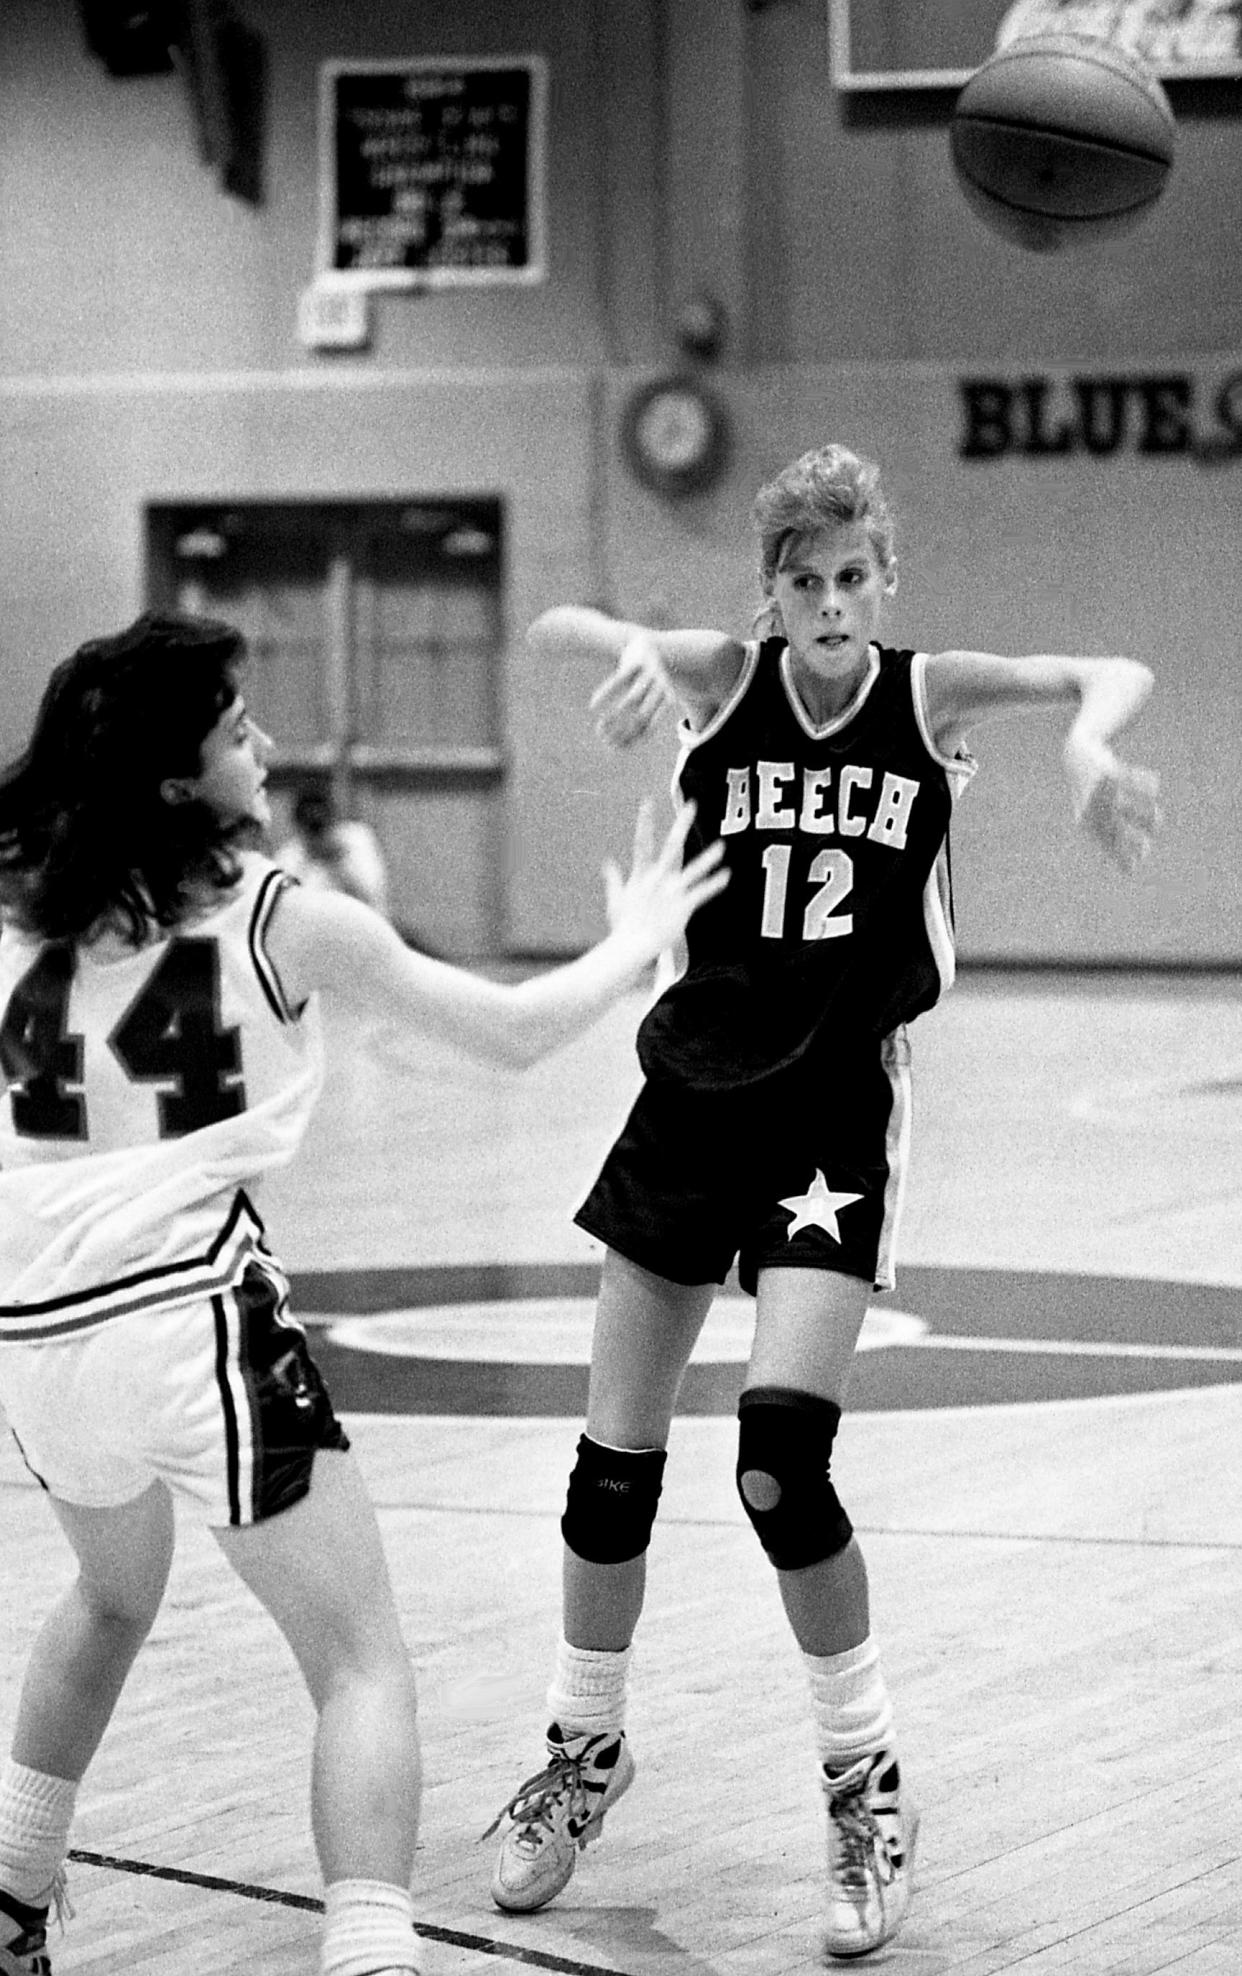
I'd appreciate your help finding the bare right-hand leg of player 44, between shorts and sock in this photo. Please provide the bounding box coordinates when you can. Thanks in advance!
[213,1450,421,1887]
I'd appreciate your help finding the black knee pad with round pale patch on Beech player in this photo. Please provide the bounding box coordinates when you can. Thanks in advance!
[737,1385,853,1571]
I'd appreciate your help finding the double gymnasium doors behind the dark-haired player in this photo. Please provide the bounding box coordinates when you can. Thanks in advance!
[148,500,504,956]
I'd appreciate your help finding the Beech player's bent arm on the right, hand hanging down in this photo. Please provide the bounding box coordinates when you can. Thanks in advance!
[926,652,1159,871]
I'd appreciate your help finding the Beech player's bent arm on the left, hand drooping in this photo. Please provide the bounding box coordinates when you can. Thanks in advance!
[527,605,744,747]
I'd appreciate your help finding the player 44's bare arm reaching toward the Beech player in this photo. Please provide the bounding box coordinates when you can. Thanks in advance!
[267,806,729,1067]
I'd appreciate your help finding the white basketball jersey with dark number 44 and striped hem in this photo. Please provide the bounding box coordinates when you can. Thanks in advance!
[0,854,324,1340]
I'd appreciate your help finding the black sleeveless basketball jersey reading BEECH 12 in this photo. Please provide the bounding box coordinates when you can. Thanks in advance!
[638,638,975,1089]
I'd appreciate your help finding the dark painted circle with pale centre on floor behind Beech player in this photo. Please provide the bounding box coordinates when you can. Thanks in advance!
[292,1263,1242,1417]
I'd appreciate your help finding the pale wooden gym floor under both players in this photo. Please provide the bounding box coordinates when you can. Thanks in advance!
[0,974,1242,1976]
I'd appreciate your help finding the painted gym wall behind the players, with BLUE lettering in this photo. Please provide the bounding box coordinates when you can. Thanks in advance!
[0,0,1242,964]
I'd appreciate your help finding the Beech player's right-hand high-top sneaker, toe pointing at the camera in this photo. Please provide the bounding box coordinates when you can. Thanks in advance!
[823,1749,918,1958]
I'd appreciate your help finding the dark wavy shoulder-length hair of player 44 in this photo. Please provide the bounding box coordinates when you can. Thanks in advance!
[0,613,255,945]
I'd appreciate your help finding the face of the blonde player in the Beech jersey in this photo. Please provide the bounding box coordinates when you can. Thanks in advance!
[772,522,891,707]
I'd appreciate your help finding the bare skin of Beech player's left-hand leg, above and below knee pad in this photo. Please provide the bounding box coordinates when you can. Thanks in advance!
[563,1251,715,1652]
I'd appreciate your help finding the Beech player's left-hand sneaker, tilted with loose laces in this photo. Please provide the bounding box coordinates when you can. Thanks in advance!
[484,1723,634,1915]
